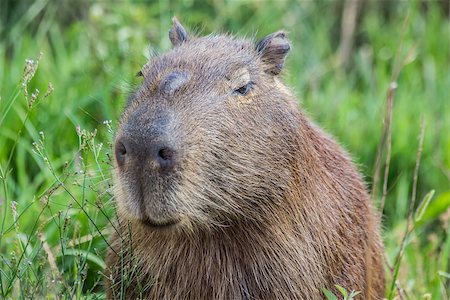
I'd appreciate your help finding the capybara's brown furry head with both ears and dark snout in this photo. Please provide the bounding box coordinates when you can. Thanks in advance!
[115,19,301,230]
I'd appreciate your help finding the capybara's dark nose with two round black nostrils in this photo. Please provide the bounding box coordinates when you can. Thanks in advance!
[115,137,176,173]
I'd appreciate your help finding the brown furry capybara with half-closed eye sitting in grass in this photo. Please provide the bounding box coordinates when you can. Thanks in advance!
[106,18,385,300]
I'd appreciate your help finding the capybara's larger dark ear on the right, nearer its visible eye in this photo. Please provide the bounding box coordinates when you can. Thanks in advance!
[256,31,291,75]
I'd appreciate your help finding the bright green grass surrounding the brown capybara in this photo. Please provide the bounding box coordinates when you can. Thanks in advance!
[0,0,450,299]
